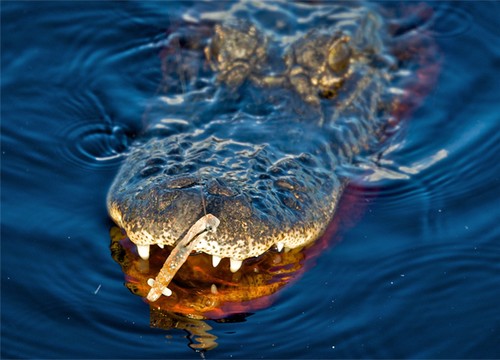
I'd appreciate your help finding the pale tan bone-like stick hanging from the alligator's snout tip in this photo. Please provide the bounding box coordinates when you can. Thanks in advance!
[147,214,221,301]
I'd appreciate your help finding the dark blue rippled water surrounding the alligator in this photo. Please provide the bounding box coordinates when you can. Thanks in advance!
[1,2,500,358]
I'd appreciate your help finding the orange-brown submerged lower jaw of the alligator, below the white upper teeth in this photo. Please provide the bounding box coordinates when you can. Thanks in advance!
[110,227,308,319]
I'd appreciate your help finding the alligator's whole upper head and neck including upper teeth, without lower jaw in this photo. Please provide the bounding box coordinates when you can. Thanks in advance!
[107,3,434,314]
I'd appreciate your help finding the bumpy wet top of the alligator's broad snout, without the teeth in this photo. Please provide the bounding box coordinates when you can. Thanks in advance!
[108,136,342,260]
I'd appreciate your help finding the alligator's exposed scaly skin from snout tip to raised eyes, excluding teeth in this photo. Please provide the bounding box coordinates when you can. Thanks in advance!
[107,9,396,260]
